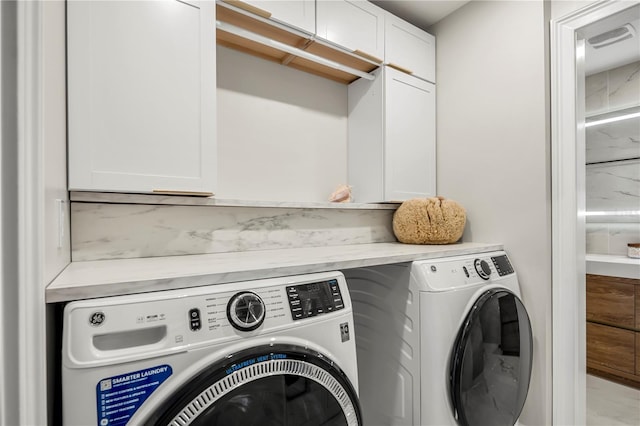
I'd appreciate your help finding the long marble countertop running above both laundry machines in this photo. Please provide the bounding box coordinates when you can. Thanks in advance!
[45,243,503,303]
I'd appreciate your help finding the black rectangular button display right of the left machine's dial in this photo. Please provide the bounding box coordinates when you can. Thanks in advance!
[287,280,344,320]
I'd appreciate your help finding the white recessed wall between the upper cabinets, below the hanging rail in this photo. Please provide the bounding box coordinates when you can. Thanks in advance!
[216,46,347,202]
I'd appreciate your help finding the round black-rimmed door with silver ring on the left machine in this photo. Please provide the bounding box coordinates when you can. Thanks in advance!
[140,345,361,426]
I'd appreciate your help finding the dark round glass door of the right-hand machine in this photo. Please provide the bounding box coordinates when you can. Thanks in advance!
[449,288,533,426]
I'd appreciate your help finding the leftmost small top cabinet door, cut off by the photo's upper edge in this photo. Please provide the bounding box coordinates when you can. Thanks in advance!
[235,0,316,34]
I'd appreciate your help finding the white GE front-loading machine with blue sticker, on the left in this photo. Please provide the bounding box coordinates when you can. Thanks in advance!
[62,272,362,426]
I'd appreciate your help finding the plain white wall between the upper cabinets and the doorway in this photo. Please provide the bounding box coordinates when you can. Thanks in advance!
[431,1,552,425]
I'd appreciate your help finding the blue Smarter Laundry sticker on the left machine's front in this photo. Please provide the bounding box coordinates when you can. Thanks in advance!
[96,364,173,426]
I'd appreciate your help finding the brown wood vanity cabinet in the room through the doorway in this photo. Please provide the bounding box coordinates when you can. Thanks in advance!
[586,274,640,388]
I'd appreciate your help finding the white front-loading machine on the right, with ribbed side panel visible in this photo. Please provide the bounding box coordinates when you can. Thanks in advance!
[343,251,532,426]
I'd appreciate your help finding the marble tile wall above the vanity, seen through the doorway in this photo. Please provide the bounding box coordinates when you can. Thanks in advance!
[585,62,640,255]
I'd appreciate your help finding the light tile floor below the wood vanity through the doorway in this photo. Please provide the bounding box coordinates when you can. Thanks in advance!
[587,374,640,426]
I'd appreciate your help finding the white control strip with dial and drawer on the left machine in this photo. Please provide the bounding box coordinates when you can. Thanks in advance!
[63,271,351,368]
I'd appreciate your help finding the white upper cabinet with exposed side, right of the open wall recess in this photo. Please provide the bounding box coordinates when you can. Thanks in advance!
[347,67,436,203]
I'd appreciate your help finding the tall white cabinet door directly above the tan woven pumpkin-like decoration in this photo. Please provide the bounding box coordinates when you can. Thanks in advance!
[384,67,436,201]
